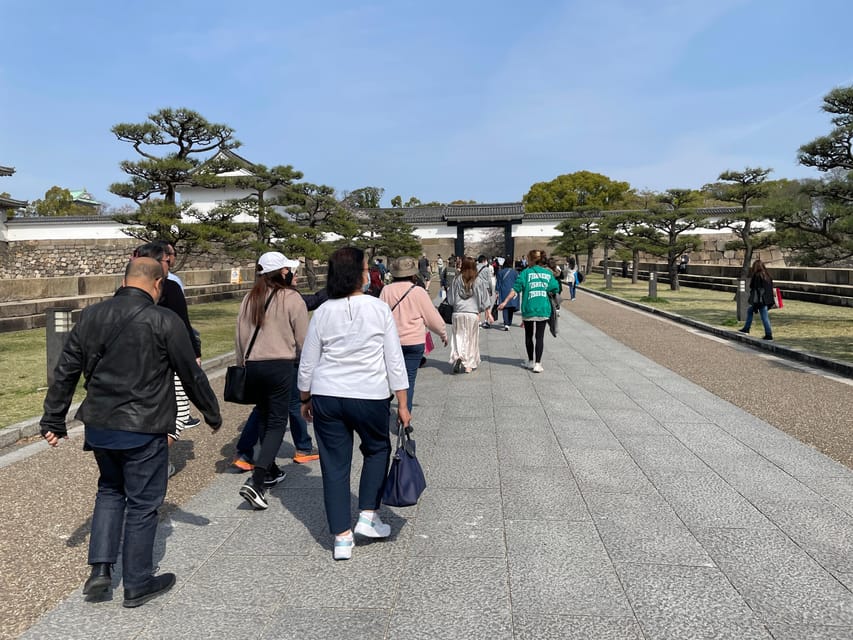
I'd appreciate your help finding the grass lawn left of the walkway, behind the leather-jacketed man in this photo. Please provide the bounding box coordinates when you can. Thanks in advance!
[0,300,240,428]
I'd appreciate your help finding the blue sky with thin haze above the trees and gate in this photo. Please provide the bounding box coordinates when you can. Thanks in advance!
[0,0,853,205]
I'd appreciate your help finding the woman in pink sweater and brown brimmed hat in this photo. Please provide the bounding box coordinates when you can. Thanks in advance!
[379,256,447,413]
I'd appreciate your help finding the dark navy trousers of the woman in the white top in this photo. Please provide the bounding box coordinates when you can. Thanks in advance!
[311,395,391,534]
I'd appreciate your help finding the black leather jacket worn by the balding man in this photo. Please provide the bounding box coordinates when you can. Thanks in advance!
[40,287,222,436]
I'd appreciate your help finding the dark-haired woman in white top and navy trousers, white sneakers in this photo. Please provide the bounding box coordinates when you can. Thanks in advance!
[298,247,411,560]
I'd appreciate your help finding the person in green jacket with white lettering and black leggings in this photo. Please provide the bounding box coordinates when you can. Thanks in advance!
[498,249,560,373]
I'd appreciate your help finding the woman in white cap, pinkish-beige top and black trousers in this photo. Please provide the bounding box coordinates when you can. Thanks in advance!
[236,251,308,509]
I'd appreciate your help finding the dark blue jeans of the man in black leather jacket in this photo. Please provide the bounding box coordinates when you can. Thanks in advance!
[89,435,169,589]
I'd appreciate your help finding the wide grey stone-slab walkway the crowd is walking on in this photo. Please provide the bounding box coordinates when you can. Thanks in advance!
[16,311,853,640]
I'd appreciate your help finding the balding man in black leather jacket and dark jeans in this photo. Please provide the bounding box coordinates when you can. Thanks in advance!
[40,258,222,607]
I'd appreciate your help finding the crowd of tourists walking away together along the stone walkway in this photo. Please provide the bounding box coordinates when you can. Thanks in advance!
[41,242,574,607]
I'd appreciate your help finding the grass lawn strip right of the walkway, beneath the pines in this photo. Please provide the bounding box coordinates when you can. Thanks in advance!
[581,273,853,362]
